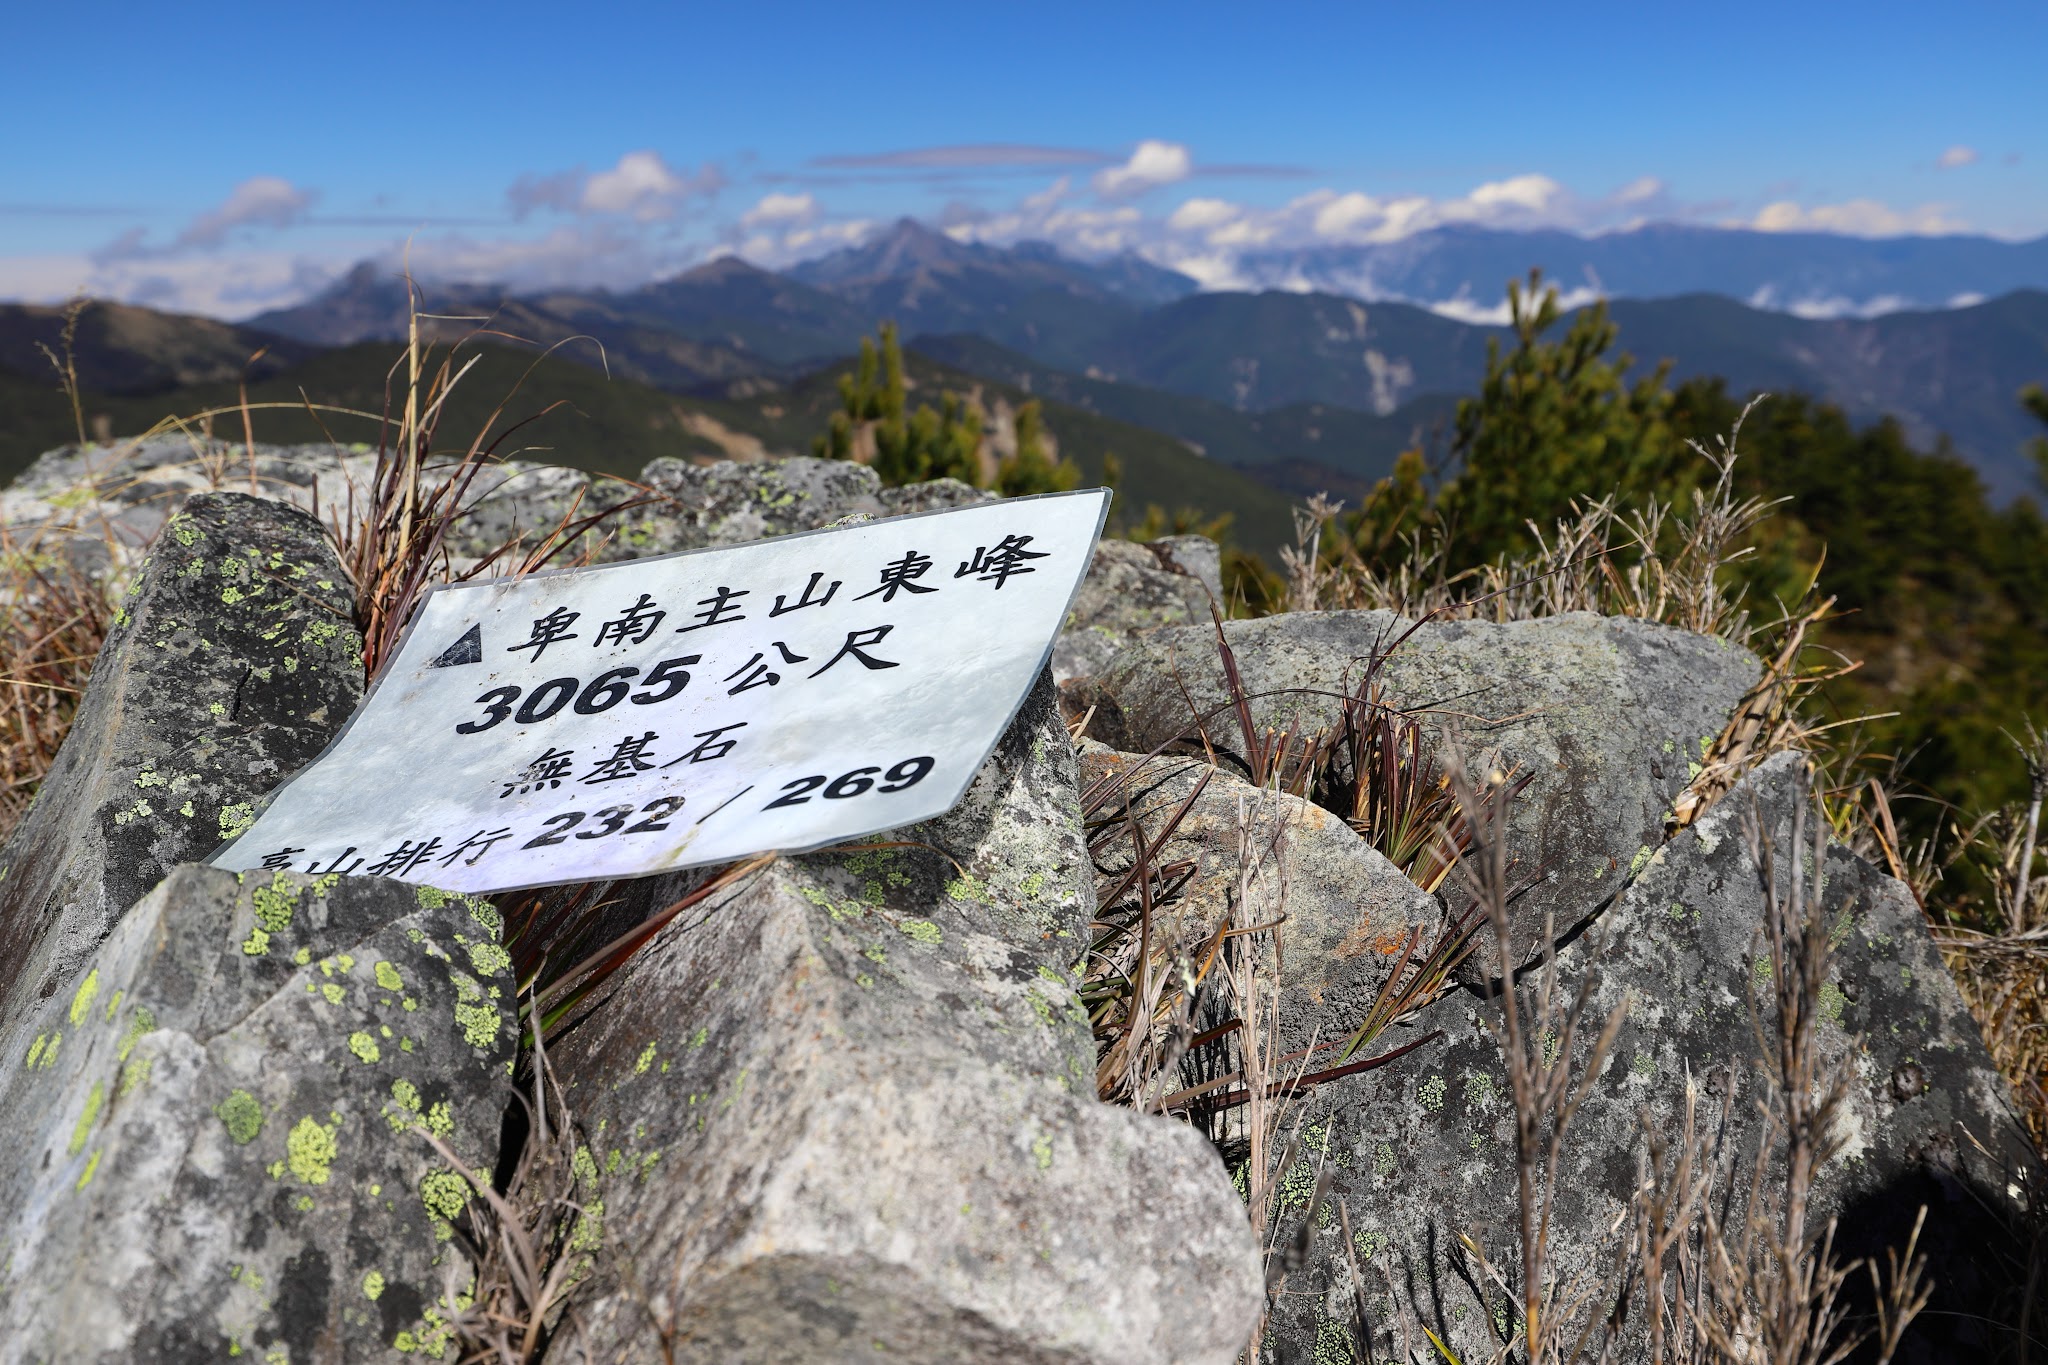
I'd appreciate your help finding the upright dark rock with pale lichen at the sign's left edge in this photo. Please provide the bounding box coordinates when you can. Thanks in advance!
[0,493,362,1021]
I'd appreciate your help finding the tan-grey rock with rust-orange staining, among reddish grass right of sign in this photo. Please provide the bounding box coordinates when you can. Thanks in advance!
[1081,745,1442,1035]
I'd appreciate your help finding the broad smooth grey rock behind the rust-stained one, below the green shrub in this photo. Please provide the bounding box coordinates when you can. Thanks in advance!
[1069,612,1759,965]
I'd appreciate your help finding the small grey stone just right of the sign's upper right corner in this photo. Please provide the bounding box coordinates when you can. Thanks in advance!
[1053,536,1223,684]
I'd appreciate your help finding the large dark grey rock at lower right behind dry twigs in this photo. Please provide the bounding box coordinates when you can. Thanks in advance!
[1266,755,2040,1365]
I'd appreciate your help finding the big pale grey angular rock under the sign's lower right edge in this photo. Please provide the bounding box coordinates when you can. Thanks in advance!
[553,684,1257,1365]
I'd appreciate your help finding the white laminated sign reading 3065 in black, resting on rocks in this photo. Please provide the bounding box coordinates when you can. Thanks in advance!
[211,489,1108,892]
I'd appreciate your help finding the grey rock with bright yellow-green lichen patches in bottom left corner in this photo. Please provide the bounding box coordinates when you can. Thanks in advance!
[0,866,516,1365]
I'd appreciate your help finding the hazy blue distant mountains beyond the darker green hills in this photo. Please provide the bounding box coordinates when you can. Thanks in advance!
[248,219,2048,495]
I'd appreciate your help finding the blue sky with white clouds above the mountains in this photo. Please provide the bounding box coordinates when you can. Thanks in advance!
[0,2,2048,315]
